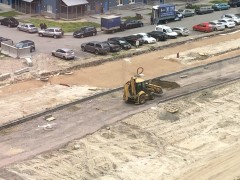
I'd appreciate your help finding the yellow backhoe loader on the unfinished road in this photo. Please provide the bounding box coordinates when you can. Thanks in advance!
[123,67,163,104]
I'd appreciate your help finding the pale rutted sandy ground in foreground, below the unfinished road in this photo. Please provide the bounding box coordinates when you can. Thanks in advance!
[5,82,240,180]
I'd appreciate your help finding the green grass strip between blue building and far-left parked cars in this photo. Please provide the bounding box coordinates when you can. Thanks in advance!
[24,18,100,32]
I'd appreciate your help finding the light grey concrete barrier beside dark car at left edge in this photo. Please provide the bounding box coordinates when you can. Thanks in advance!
[1,41,31,58]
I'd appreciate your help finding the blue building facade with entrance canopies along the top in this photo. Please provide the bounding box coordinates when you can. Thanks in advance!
[0,0,144,20]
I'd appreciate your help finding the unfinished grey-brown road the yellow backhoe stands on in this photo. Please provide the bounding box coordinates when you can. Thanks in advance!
[0,57,240,167]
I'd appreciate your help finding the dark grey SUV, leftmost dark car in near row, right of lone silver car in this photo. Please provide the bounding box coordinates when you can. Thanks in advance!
[81,41,110,54]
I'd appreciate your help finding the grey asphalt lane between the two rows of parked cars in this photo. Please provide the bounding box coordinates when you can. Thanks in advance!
[0,8,240,53]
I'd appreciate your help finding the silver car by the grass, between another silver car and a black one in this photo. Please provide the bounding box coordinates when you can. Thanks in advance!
[38,27,64,39]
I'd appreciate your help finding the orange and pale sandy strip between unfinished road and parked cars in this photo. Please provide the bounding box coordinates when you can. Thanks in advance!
[0,32,240,124]
